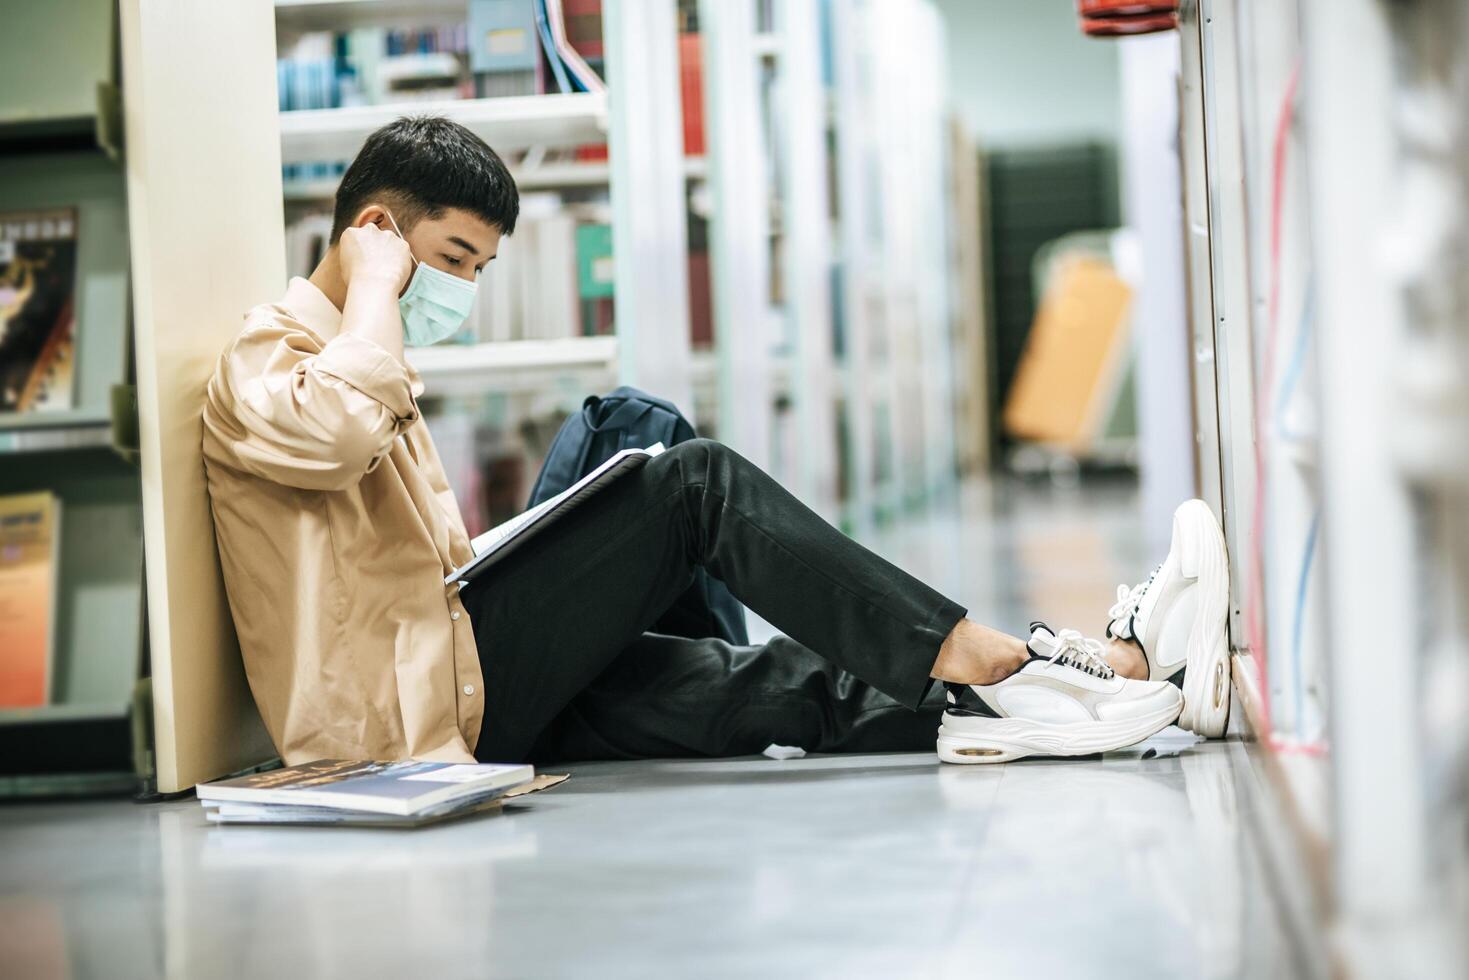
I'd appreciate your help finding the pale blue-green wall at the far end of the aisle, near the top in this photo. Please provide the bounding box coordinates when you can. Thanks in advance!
[934,0,1122,147]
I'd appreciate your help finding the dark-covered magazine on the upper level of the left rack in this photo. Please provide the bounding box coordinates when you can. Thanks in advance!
[0,209,76,413]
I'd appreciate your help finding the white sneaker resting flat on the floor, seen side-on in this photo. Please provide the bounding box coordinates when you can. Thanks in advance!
[939,623,1183,764]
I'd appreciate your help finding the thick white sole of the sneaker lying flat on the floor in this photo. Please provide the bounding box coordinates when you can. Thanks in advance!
[937,696,1183,765]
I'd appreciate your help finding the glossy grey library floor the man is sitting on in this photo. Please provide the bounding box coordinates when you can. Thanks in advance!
[0,473,1306,979]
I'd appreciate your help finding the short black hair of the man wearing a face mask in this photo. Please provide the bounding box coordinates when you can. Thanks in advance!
[332,116,520,245]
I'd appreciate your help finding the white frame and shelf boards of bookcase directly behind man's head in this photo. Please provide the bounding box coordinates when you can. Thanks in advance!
[275,0,708,401]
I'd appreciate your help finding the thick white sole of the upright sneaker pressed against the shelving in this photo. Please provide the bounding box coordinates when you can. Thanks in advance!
[1174,500,1231,739]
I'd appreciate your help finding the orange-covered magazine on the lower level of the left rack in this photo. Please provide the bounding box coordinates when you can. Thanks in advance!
[0,492,62,708]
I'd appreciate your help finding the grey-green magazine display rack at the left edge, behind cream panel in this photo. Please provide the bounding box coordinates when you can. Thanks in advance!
[0,0,144,795]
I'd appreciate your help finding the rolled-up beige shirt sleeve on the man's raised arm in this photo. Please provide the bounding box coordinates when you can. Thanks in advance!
[206,322,419,491]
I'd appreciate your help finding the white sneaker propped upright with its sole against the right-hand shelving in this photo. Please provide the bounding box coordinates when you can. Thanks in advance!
[1106,500,1230,739]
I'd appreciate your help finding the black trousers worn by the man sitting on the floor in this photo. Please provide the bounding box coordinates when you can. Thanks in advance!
[461,439,965,763]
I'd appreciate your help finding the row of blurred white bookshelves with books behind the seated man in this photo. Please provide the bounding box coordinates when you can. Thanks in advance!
[276,0,978,533]
